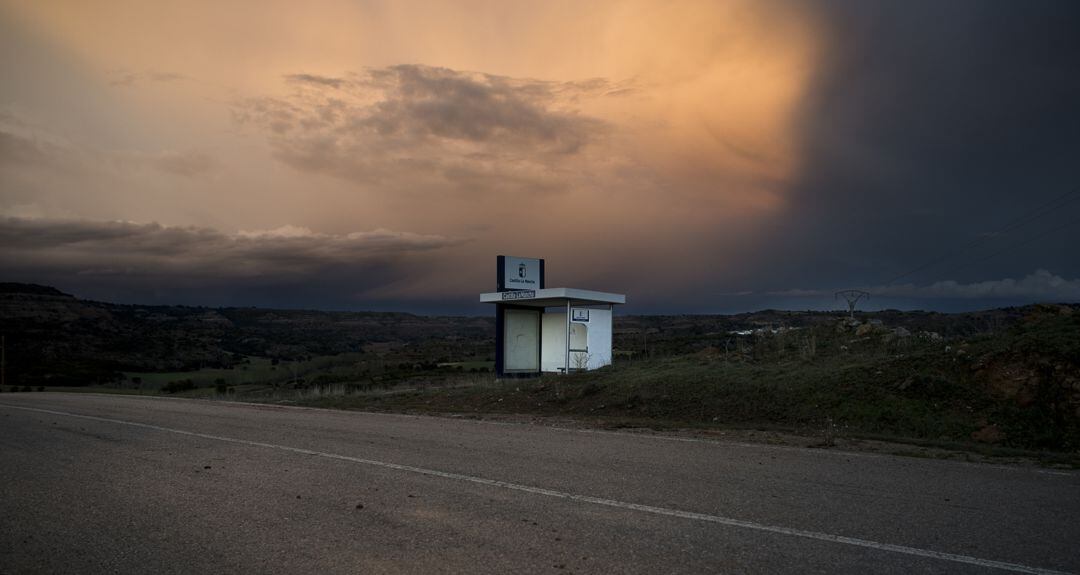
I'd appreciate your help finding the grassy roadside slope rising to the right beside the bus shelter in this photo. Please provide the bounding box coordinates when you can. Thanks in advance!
[287,310,1080,452]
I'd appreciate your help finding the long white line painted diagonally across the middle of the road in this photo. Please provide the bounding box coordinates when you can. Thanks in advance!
[0,403,1068,575]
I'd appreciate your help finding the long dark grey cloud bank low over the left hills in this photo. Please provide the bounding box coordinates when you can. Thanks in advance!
[0,217,458,298]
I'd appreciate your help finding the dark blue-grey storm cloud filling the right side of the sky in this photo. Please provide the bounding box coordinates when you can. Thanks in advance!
[762,0,1080,304]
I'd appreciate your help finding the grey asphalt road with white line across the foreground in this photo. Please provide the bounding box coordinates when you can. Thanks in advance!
[0,393,1080,573]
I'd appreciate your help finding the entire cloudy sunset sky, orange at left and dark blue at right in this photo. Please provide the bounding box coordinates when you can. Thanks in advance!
[0,0,1080,315]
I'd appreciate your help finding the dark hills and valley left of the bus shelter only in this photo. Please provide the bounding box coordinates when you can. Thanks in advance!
[0,283,494,385]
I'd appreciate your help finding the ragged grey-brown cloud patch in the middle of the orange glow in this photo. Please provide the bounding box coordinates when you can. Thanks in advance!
[233,66,609,190]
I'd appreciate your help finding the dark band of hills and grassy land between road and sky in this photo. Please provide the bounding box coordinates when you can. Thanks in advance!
[0,289,1080,457]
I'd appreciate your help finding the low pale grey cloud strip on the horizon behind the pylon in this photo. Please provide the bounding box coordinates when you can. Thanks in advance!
[767,269,1080,302]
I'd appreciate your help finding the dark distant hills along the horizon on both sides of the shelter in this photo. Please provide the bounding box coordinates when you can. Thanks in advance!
[0,283,1067,385]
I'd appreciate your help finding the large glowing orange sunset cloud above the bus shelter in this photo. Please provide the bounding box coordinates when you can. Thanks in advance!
[0,0,819,302]
